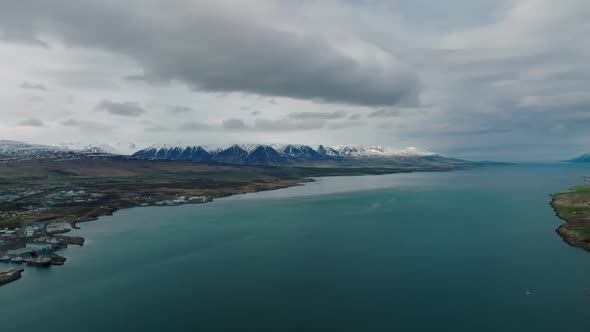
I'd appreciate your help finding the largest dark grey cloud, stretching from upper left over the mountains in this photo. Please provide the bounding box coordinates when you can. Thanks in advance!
[0,0,420,105]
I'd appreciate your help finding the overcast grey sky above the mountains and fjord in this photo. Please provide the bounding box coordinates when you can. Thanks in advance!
[0,0,590,160]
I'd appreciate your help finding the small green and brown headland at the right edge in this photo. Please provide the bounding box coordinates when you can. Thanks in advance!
[551,185,590,251]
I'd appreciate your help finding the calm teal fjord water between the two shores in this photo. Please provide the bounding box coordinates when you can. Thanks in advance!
[0,164,590,332]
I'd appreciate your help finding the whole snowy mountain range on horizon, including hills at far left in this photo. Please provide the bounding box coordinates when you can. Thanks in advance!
[0,140,508,169]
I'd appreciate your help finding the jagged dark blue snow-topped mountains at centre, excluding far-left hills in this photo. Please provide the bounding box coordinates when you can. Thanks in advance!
[132,144,473,167]
